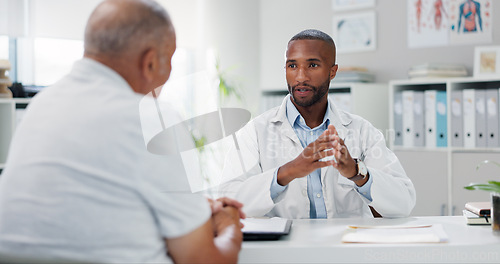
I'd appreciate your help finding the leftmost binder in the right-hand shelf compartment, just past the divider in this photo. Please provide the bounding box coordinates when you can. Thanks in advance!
[450,90,464,147]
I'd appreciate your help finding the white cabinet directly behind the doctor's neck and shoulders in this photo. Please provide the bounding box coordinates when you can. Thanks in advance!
[261,82,389,135]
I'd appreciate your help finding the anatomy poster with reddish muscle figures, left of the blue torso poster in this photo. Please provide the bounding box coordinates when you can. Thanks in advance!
[408,0,450,48]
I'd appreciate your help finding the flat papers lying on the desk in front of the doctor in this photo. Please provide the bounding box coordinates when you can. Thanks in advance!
[342,224,448,243]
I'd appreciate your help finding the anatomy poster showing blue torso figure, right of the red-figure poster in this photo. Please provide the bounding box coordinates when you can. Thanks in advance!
[450,0,493,44]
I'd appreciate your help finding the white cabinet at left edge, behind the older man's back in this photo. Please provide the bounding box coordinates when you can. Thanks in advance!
[0,98,30,172]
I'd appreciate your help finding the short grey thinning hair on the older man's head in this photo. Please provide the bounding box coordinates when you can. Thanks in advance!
[84,0,173,56]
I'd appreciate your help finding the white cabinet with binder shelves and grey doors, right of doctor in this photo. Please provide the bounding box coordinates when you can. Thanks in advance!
[388,78,500,216]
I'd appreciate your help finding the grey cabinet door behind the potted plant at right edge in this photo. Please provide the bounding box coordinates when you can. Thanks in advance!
[451,152,500,215]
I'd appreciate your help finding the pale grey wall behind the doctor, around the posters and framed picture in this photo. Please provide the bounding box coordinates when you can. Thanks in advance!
[260,0,500,90]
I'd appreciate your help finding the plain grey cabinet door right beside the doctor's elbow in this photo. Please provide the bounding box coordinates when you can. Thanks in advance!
[394,150,448,216]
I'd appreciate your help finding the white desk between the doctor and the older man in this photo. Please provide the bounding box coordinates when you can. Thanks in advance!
[239,216,500,263]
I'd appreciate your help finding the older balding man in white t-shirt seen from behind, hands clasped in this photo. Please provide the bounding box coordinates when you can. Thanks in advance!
[0,0,244,263]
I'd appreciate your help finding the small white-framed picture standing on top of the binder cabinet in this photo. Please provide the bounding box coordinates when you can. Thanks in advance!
[474,46,500,78]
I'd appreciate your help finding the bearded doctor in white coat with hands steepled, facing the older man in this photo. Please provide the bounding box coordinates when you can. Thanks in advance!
[221,30,416,218]
